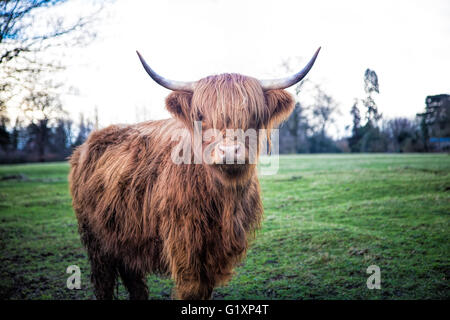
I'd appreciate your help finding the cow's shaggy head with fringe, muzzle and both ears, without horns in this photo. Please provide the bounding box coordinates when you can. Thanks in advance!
[166,74,294,182]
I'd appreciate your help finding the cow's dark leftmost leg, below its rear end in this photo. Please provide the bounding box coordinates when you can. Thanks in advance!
[91,255,117,300]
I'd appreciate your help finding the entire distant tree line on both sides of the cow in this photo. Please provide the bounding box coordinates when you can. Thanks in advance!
[0,69,450,163]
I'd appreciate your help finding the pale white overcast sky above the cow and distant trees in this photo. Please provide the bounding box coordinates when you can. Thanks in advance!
[60,0,450,134]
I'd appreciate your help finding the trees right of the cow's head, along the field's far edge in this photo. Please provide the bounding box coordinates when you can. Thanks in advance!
[279,69,450,153]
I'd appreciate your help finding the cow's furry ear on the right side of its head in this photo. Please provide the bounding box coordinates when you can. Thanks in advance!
[265,90,294,128]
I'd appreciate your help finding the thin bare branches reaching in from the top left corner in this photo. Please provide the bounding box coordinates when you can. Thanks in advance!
[0,0,106,114]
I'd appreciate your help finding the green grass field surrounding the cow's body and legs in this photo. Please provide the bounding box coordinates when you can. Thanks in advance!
[0,154,450,299]
